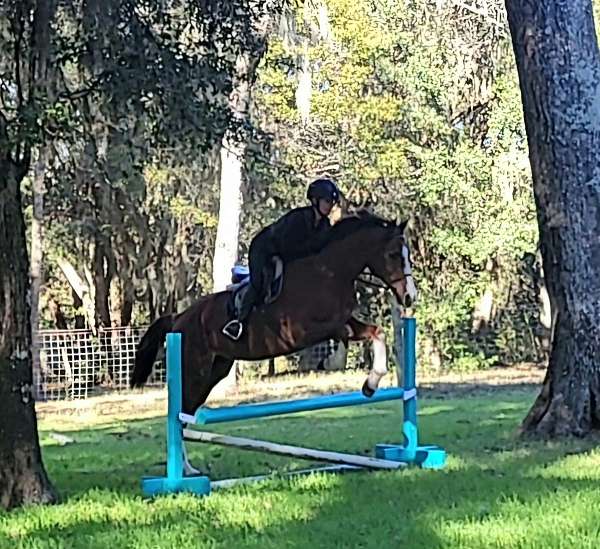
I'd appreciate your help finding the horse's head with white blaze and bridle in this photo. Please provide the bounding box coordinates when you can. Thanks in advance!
[368,221,417,307]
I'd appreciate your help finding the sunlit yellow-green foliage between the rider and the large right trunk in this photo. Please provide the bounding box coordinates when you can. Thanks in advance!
[248,0,537,367]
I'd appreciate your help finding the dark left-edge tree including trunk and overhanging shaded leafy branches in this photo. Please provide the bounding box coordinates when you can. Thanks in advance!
[0,0,286,508]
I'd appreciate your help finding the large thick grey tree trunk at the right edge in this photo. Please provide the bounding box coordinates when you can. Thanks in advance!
[506,0,600,436]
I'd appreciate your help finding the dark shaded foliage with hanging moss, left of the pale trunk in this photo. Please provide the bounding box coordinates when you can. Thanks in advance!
[0,0,281,322]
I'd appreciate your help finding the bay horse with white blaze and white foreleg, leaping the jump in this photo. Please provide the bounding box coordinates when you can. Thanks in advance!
[131,212,417,415]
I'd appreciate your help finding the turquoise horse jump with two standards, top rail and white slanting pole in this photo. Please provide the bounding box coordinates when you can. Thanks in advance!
[142,318,446,496]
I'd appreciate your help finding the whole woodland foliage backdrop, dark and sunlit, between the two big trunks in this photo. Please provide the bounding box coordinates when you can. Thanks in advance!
[8,0,541,368]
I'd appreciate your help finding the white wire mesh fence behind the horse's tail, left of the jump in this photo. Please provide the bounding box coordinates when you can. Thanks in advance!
[34,327,165,401]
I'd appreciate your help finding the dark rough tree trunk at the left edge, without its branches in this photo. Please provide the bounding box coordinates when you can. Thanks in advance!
[0,0,56,508]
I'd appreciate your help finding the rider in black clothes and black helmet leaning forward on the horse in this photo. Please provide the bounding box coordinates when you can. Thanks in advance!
[223,178,340,340]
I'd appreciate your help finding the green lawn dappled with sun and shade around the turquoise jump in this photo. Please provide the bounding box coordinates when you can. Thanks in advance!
[0,389,600,549]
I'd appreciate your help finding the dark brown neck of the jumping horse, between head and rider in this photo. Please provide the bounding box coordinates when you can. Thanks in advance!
[321,229,377,280]
